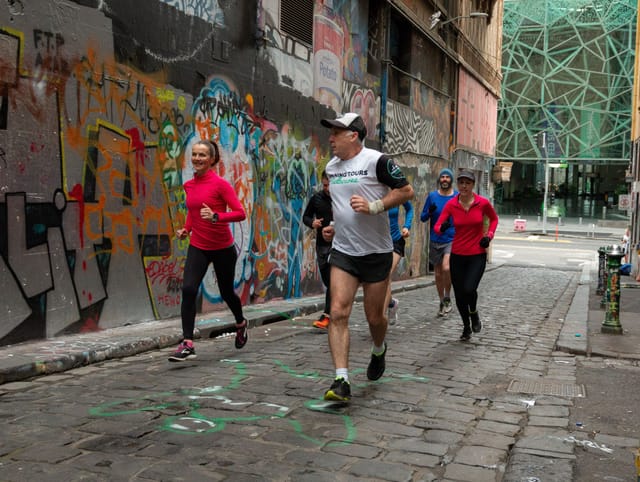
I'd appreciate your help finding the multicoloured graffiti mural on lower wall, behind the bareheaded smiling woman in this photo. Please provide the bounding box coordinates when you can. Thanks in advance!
[0,2,326,344]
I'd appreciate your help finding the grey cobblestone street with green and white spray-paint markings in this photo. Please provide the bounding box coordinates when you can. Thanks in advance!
[0,266,592,482]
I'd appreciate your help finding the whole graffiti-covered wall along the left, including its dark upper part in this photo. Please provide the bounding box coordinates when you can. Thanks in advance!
[0,0,442,345]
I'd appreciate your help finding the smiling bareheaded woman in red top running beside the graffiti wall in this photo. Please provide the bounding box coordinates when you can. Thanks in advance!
[169,140,247,361]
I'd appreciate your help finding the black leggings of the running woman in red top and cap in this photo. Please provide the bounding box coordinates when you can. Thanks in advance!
[449,253,487,327]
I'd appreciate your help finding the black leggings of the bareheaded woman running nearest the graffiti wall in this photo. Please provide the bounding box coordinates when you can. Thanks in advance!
[180,245,244,340]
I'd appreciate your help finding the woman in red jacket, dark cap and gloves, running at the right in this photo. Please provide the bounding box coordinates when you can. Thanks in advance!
[434,171,498,341]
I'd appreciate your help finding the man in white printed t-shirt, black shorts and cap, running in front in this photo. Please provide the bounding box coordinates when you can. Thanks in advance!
[321,113,413,402]
